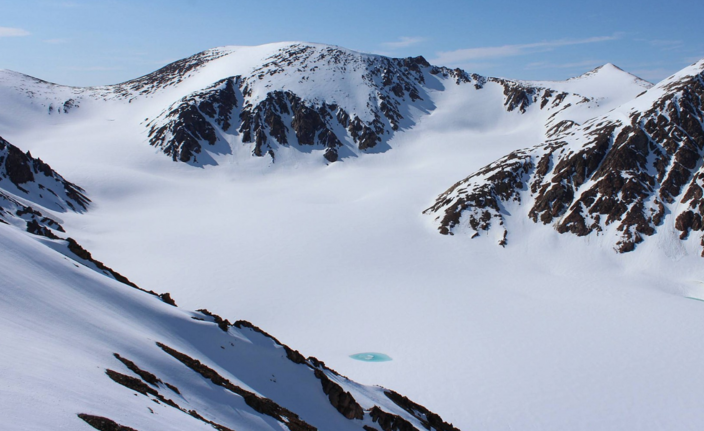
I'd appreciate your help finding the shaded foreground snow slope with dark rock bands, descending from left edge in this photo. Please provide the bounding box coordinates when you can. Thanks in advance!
[0,219,468,431]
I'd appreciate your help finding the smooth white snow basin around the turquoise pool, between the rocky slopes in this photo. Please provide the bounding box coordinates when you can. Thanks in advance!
[0,44,704,431]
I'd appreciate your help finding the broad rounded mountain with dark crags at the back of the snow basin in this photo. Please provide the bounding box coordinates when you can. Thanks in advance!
[0,43,648,166]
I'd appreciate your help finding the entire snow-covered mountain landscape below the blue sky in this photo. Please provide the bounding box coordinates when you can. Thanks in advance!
[0,42,704,431]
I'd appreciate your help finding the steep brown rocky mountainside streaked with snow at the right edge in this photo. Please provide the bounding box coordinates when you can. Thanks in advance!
[426,61,704,255]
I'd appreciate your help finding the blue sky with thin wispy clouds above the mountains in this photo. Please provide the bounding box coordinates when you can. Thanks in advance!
[0,0,704,86]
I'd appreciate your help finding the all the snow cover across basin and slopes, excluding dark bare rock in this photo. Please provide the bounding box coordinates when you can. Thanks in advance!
[0,44,704,431]
